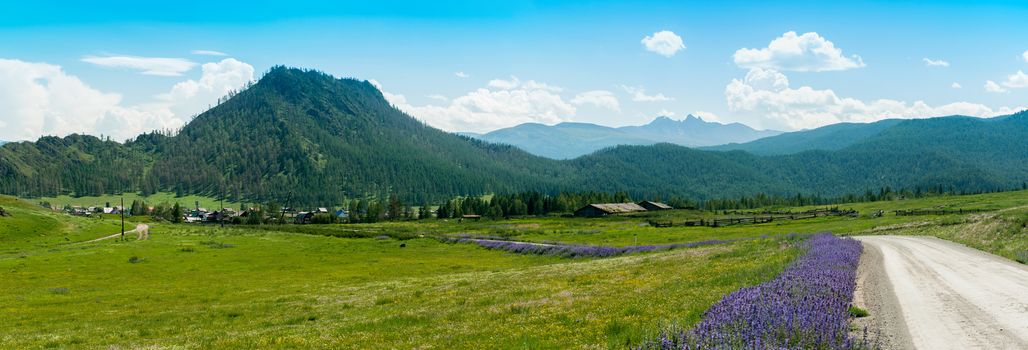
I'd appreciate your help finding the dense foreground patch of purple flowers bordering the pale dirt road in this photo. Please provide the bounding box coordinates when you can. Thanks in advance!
[641,234,868,349]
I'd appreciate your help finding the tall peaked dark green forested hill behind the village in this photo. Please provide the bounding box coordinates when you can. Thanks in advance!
[140,67,563,203]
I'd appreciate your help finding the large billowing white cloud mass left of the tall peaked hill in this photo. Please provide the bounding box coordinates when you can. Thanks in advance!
[0,59,253,140]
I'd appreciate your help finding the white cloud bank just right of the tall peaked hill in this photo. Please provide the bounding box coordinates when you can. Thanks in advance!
[369,77,577,132]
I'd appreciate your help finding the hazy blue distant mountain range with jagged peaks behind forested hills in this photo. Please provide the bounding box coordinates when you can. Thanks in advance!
[460,115,781,160]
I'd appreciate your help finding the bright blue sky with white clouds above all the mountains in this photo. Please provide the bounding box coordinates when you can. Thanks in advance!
[0,1,1028,140]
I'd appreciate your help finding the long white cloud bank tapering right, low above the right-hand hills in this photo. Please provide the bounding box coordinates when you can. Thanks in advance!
[725,68,1021,130]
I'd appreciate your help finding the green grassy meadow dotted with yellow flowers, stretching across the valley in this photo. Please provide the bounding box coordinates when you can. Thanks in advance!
[0,191,1028,349]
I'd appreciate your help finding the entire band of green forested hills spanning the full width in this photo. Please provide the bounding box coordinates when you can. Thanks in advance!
[0,67,1028,205]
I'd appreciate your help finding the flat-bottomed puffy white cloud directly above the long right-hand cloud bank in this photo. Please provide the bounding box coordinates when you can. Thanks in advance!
[734,32,865,72]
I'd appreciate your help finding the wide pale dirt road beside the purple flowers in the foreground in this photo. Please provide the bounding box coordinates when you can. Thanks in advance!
[854,236,1028,349]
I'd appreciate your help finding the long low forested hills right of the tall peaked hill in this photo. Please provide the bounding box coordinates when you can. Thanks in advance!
[572,111,1028,198]
